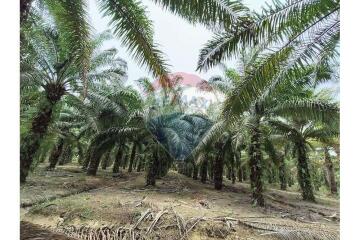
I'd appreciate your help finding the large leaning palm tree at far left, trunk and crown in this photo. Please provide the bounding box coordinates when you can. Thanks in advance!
[20,25,126,183]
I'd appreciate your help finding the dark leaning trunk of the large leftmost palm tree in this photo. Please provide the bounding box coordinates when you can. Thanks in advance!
[20,84,65,183]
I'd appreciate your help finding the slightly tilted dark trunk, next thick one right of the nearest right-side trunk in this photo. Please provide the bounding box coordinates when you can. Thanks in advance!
[297,143,315,202]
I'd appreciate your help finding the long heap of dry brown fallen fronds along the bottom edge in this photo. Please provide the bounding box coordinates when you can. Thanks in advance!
[50,207,340,240]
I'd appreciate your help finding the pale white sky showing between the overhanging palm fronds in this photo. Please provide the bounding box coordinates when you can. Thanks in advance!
[89,0,265,84]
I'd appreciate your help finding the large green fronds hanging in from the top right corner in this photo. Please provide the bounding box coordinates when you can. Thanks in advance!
[198,0,340,116]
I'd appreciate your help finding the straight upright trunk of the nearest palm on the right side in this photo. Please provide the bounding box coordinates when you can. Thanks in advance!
[249,120,265,206]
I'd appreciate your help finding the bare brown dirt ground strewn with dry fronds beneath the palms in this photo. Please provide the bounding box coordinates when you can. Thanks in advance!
[21,165,340,240]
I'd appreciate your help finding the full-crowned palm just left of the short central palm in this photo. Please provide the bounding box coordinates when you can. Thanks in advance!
[67,85,142,175]
